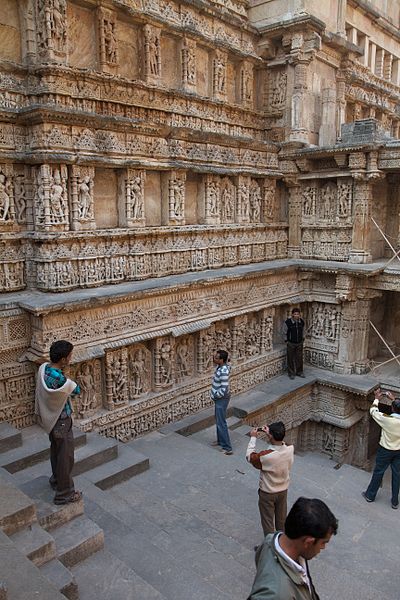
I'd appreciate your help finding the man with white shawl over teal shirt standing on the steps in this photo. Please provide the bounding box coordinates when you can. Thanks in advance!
[35,340,82,504]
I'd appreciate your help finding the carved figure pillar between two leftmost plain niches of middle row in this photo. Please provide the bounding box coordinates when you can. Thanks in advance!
[118,169,146,227]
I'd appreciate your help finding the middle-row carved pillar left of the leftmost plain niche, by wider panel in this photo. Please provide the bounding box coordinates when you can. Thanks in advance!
[70,165,96,231]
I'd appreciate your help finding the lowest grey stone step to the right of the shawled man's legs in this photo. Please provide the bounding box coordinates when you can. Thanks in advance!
[82,443,150,490]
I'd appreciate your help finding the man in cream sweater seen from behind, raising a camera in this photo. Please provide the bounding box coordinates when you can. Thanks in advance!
[246,421,294,535]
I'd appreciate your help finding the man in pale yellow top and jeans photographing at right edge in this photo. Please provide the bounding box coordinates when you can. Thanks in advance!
[362,388,400,509]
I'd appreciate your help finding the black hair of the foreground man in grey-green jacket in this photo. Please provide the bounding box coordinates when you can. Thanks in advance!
[285,497,338,540]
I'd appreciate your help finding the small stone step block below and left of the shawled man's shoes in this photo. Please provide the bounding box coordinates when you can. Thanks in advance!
[10,523,56,567]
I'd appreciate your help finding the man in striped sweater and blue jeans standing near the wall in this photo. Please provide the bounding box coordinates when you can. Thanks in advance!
[210,350,233,455]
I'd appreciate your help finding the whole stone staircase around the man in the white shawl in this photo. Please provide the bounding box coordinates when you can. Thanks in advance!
[0,423,149,600]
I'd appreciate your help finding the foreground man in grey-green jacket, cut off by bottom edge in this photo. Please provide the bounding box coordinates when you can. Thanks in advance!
[247,498,338,600]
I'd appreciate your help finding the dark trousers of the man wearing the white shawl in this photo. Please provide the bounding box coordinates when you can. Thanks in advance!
[49,417,74,499]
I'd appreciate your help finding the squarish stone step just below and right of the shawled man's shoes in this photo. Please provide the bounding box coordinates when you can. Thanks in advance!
[52,515,104,567]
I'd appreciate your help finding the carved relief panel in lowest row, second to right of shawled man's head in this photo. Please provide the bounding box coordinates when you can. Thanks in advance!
[105,348,128,410]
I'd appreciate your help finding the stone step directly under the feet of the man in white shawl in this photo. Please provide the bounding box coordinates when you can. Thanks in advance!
[19,476,84,531]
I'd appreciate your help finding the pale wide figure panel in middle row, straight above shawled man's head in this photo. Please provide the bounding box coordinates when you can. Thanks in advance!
[34,165,69,231]
